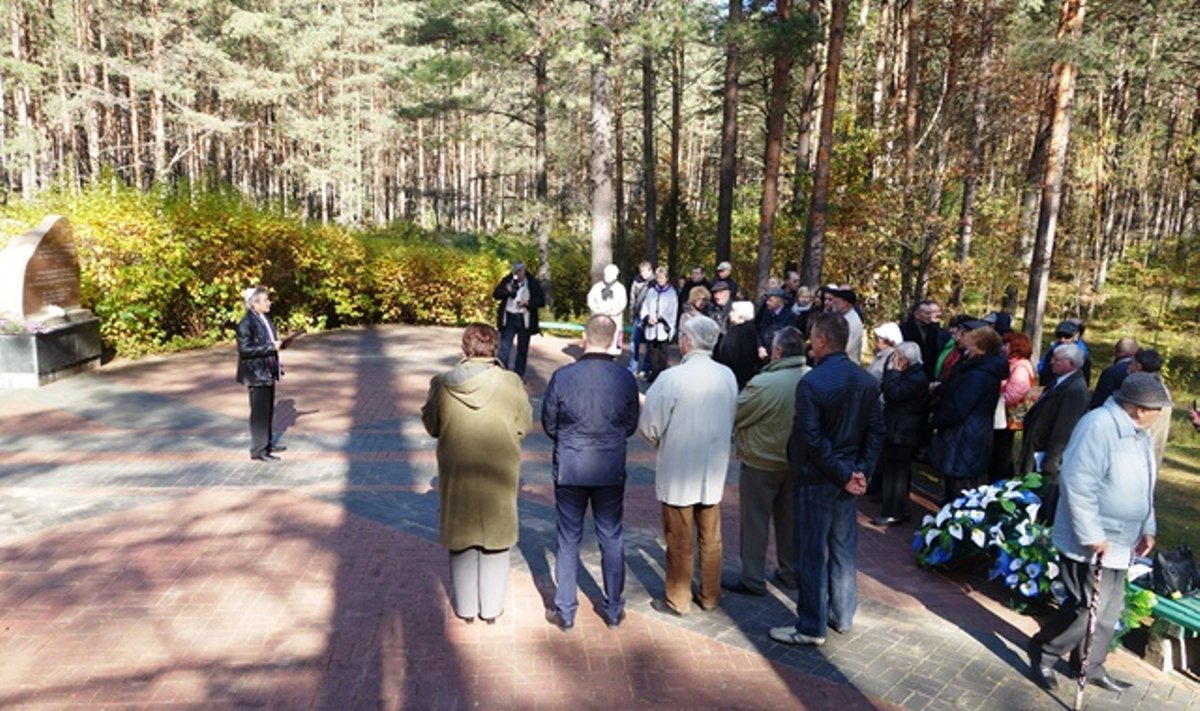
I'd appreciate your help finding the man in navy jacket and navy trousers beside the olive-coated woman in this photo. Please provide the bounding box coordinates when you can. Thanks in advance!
[541,315,638,632]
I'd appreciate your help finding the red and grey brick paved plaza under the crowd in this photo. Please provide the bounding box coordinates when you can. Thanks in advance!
[0,327,1200,711]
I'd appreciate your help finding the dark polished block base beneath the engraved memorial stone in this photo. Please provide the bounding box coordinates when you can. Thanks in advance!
[0,313,101,389]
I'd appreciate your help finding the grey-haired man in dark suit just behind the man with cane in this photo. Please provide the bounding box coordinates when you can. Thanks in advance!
[1019,343,1091,522]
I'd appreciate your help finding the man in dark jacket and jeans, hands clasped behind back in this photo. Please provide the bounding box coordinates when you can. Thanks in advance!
[770,311,884,645]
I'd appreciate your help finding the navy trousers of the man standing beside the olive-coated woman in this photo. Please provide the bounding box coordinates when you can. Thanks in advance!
[554,484,625,622]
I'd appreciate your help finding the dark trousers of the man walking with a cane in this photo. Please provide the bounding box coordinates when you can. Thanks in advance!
[1031,557,1126,675]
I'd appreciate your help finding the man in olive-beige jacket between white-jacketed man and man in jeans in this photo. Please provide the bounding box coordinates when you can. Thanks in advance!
[721,325,809,596]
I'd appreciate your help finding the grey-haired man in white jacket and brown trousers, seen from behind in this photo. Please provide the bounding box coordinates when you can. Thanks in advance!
[637,316,738,616]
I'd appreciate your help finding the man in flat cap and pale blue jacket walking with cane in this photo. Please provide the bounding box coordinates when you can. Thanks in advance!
[1028,372,1171,692]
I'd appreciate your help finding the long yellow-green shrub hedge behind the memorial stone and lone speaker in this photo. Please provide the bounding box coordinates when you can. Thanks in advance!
[0,185,587,357]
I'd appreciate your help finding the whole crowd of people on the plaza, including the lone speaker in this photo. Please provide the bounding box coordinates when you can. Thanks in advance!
[239,262,1200,689]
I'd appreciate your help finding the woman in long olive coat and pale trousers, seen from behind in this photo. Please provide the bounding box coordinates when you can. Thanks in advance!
[421,323,533,625]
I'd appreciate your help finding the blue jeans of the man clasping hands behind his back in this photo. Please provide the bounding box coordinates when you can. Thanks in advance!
[793,484,858,637]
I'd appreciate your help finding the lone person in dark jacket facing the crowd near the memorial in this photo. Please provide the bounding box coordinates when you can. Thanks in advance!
[238,286,284,461]
